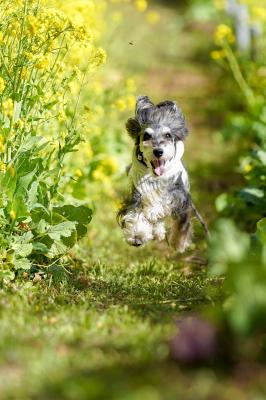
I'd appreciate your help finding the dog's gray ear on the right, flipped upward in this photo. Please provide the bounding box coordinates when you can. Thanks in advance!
[156,100,188,141]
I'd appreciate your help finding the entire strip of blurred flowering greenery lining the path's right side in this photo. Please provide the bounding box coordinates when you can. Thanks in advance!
[210,0,266,340]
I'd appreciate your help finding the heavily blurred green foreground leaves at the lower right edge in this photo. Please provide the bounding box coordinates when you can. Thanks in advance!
[210,218,266,335]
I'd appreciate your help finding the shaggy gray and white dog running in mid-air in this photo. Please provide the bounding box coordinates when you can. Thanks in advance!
[118,96,207,252]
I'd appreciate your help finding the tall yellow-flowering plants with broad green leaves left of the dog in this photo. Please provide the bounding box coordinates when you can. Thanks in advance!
[0,0,109,279]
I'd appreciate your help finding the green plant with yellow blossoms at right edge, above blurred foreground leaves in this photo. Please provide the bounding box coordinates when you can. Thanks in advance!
[211,0,266,229]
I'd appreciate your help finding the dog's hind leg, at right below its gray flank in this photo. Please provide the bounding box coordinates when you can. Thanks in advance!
[170,211,192,253]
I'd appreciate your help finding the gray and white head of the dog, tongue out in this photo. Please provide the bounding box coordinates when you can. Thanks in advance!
[126,96,188,176]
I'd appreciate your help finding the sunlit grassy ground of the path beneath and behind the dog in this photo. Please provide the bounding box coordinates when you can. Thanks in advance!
[0,1,264,400]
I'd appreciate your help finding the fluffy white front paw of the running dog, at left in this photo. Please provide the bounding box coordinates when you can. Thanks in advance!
[122,209,153,246]
